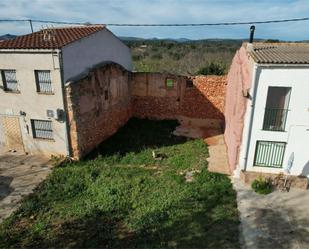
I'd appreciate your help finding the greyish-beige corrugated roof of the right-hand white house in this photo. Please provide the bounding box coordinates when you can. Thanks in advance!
[249,43,309,64]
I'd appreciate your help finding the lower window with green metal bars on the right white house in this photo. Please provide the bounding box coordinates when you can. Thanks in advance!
[254,141,286,168]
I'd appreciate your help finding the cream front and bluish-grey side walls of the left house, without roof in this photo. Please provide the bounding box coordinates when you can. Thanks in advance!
[0,28,132,155]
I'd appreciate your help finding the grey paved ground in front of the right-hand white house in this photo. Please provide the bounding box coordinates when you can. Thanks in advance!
[234,179,309,249]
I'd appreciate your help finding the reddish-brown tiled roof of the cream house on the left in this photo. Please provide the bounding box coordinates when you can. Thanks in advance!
[0,25,105,49]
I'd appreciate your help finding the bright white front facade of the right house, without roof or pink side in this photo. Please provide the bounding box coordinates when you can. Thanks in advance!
[239,64,309,176]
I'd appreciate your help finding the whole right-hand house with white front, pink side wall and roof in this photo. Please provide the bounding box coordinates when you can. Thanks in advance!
[225,43,309,179]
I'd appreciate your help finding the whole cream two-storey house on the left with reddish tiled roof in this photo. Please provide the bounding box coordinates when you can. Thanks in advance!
[0,25,132,158]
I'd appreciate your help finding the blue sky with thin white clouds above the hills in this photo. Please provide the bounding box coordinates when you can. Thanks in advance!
[0,0,309,41]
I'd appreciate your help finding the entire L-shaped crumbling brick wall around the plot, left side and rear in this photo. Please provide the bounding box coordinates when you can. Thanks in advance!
[66,63,226,158]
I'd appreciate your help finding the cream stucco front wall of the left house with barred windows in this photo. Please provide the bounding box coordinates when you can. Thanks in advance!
[0,50,67,155]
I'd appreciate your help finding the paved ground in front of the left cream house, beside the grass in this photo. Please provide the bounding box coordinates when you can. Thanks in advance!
[0,153,51,222]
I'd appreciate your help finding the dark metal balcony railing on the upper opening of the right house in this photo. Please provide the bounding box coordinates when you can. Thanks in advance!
[263,108,289,131]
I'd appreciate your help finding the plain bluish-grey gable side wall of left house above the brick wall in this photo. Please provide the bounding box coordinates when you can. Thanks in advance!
[62,28,132,82]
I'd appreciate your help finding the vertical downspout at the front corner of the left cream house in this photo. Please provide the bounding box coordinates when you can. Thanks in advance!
[58,51,72,156]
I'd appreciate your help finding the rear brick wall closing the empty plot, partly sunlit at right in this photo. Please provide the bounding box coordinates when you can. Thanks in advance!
[132,73,226,124]
